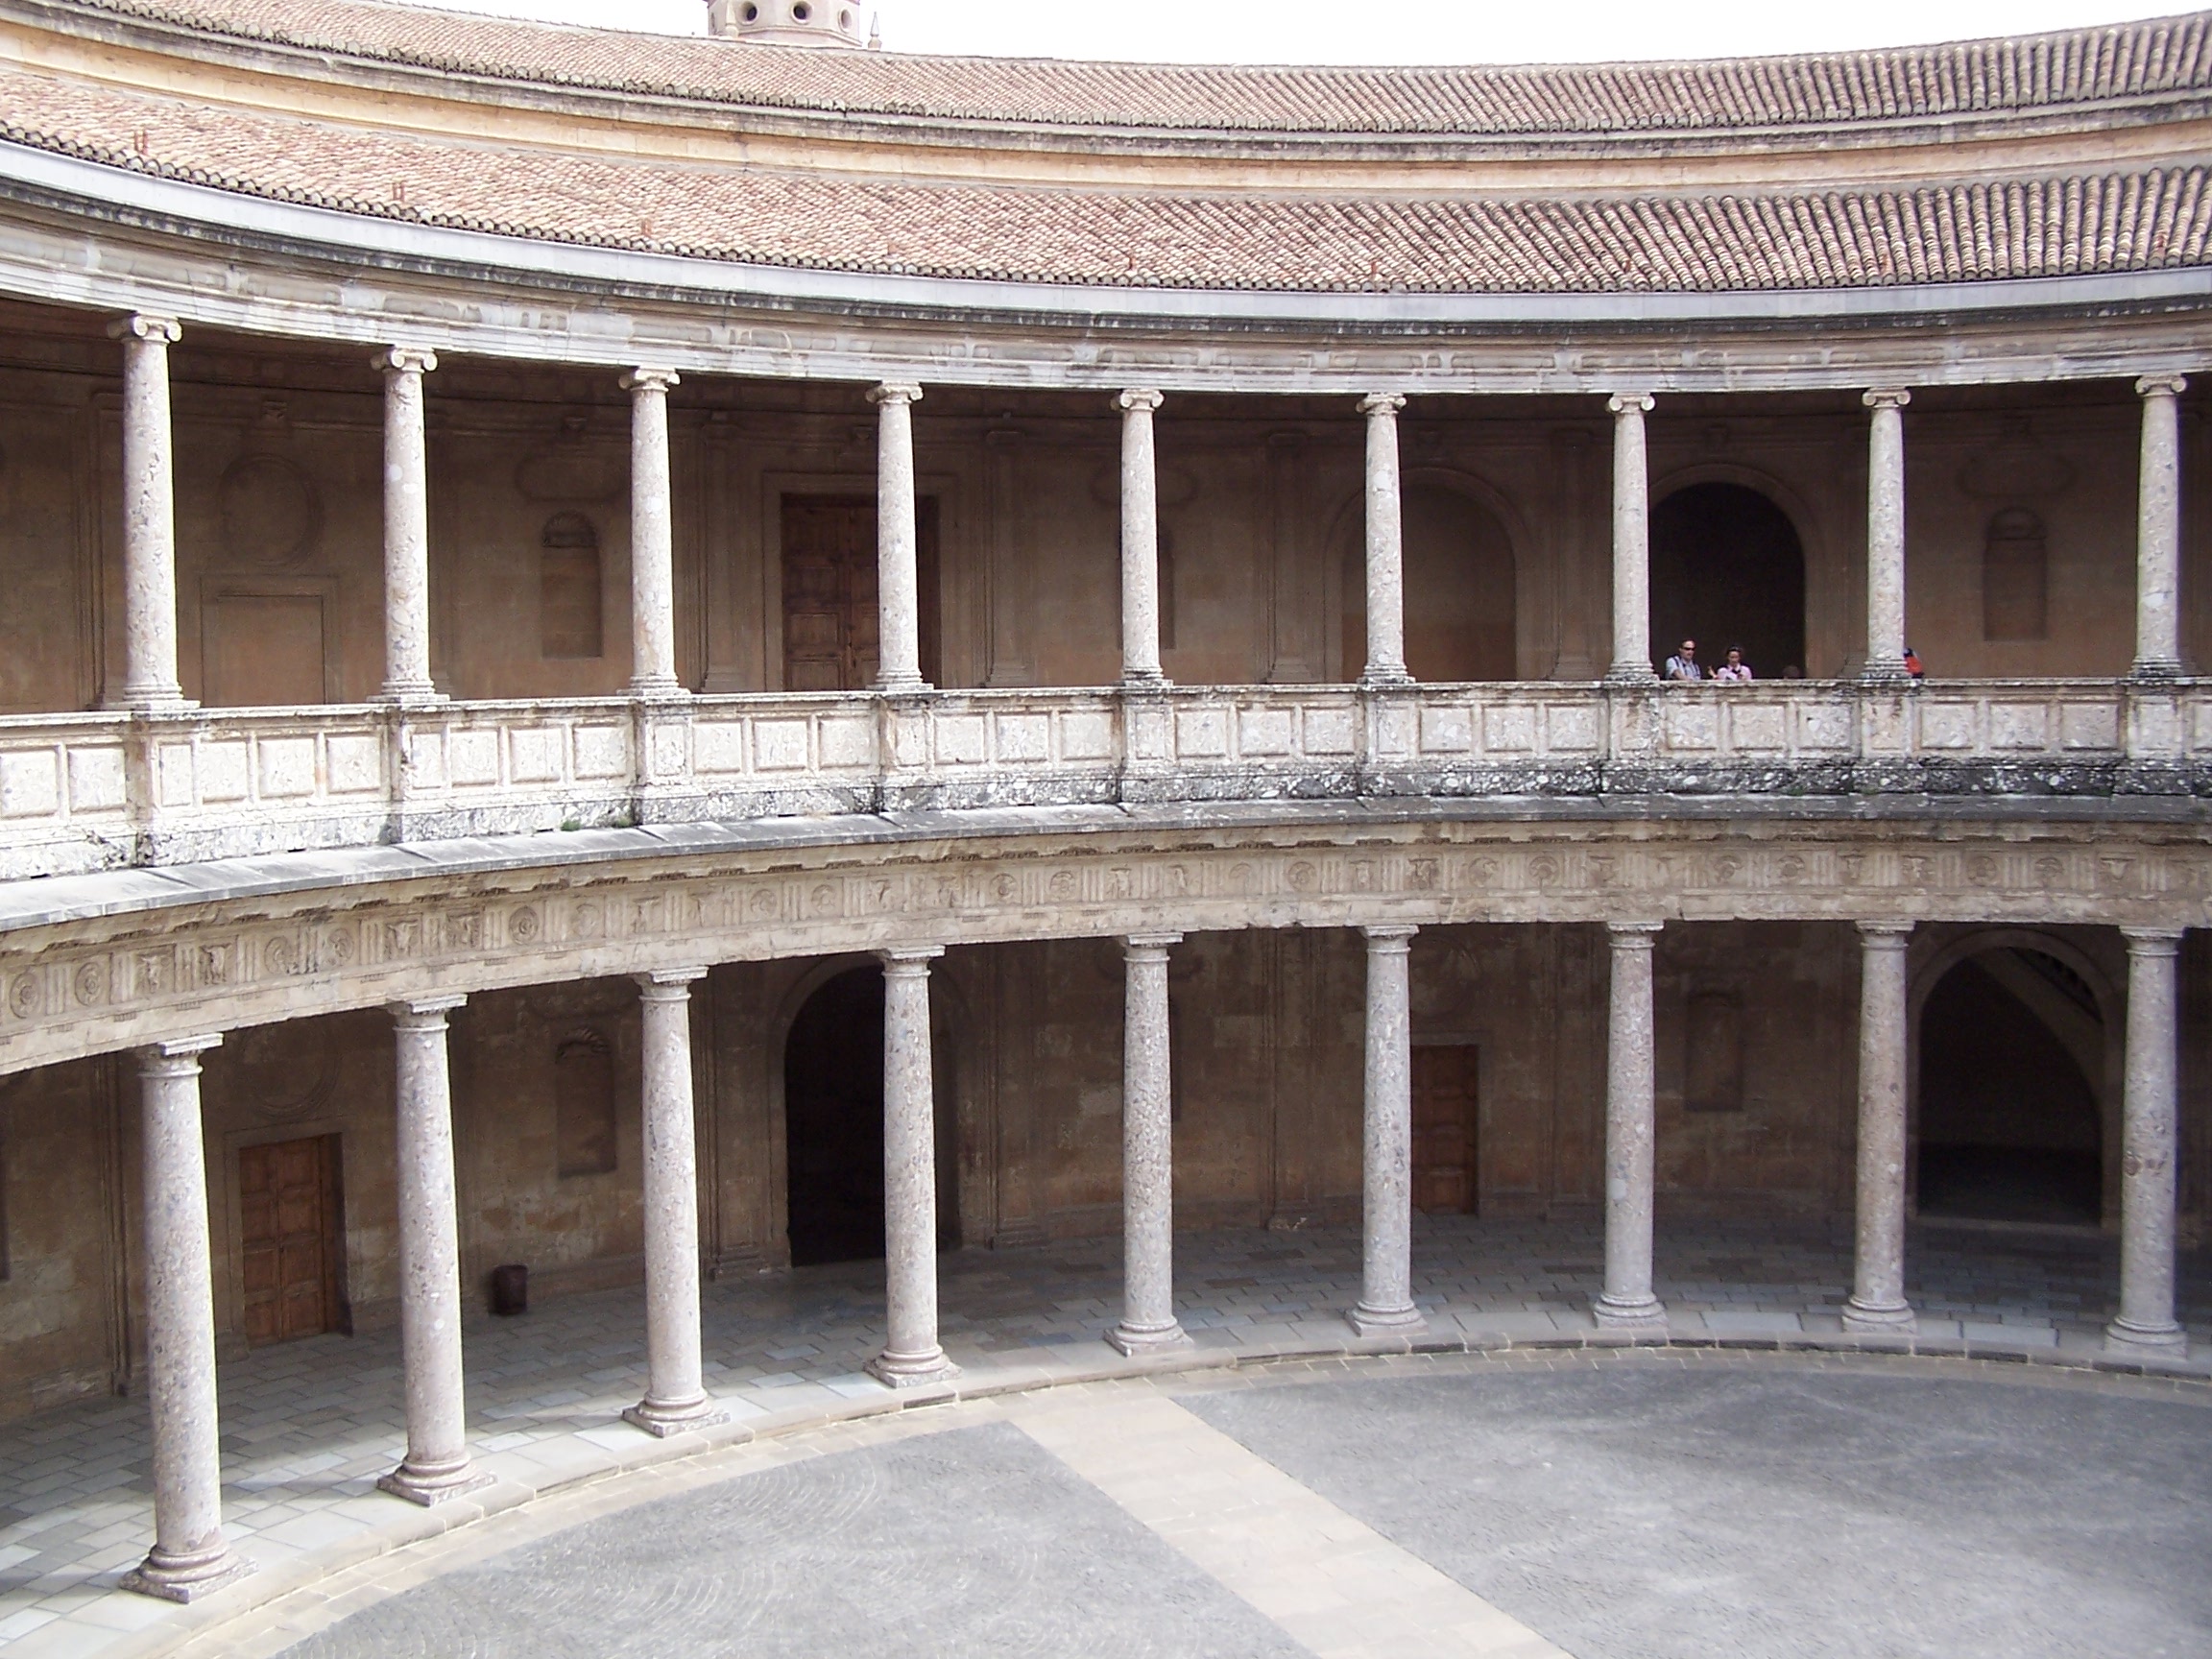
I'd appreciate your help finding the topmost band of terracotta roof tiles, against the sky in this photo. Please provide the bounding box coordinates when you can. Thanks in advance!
[56,0,2212,135]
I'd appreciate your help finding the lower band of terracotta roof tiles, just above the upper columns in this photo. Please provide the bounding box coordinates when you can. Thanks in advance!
[0,68,2212,292]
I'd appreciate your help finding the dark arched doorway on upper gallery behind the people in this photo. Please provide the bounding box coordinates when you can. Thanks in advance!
[1650,482,1805,679]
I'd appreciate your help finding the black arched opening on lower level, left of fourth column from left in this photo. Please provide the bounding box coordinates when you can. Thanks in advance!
[783,967,882,1267]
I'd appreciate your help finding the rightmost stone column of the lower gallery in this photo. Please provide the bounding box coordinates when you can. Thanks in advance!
[2104,926,2190,1356]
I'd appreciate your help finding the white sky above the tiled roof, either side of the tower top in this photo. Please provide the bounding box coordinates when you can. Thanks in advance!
[429,0,2178,64]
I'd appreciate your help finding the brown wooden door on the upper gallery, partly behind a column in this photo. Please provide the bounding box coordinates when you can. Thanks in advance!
[783,495,938,690]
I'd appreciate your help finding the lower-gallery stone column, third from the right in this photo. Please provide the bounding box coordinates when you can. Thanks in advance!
[1591,923,1666,1330]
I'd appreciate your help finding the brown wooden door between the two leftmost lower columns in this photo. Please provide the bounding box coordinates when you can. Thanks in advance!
[239,1135,343,1343]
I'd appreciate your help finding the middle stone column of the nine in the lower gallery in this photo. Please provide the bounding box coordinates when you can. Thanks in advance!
[1106,933,1190,1354]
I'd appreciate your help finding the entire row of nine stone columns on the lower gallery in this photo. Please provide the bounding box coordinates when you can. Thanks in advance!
[108,918,2185,1601]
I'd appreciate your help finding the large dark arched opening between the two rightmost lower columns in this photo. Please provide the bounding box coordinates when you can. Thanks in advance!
[1920,949,2104,1225]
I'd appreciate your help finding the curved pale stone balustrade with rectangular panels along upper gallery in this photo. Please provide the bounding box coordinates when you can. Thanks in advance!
[0,679,2212,878]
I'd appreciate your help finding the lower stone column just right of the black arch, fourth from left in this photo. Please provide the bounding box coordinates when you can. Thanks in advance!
[867,945,960,1389]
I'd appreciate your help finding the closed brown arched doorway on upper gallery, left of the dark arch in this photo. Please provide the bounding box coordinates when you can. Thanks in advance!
[1343,480,1518,682]
